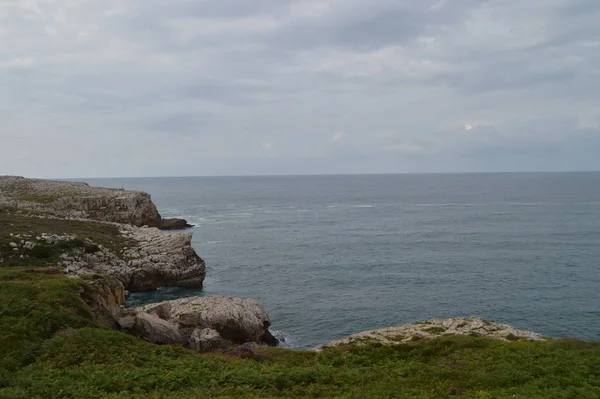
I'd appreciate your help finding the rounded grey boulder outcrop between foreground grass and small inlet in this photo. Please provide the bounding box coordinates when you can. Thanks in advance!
[119,297,277,352]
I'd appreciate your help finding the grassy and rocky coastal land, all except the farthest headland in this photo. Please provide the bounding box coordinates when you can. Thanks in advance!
[0,178,600,398]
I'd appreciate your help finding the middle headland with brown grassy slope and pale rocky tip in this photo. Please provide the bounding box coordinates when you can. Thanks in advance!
[0,218,206,291]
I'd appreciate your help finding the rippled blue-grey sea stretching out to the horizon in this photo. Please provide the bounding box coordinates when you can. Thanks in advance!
[87,173,600,348]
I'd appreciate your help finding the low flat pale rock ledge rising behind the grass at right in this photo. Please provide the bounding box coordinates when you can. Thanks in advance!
[314,317,544,351]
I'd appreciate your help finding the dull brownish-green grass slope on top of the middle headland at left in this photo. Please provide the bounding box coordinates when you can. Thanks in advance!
[0,209,137,267]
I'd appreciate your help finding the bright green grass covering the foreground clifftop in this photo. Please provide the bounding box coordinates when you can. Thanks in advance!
[0,267,600,399]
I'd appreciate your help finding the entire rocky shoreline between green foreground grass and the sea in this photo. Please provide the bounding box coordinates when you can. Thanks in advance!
[0,176,544,352]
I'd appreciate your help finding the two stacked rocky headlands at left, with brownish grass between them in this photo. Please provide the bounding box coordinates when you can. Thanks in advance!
[0,177,206,291]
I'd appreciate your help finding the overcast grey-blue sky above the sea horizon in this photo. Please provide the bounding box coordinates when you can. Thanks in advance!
[0,0,600,178]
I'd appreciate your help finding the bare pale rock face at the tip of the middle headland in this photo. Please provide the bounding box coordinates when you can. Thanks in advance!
[59,225,206,291]
